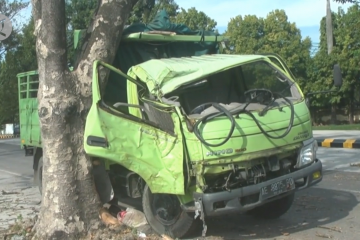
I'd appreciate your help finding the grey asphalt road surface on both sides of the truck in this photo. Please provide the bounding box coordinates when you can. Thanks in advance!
[0,135,360,240]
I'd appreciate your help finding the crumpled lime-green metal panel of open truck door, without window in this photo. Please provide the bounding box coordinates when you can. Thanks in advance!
[84,62,185,195]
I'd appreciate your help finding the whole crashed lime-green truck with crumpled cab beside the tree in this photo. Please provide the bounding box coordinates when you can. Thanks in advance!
[18,12,341,237]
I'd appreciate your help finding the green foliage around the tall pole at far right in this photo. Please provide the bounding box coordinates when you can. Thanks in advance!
[307,4,360,107]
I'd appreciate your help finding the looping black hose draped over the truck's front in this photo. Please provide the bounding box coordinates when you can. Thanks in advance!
[194,93,295,147]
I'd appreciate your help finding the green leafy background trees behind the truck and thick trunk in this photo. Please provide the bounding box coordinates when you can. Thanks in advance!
[0,0,360,125]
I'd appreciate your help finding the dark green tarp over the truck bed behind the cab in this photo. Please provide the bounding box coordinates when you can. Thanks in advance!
[105,10,219,103]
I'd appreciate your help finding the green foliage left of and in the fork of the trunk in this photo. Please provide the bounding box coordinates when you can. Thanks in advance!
[0,0,97,124]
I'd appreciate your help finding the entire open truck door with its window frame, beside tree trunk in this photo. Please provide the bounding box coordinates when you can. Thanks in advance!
[84,61,184,195]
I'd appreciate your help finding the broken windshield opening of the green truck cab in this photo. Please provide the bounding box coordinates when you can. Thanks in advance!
[168,61,300,113]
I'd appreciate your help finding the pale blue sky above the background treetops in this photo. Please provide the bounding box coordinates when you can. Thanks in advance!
[19,0,351,43]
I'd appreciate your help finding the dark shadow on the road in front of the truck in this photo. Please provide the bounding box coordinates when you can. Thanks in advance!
[188,188,359,240]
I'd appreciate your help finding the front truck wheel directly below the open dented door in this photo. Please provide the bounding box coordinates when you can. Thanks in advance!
[142,185,197,238]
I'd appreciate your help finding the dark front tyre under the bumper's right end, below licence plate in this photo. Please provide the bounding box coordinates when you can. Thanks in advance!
[247,193,295,219]
